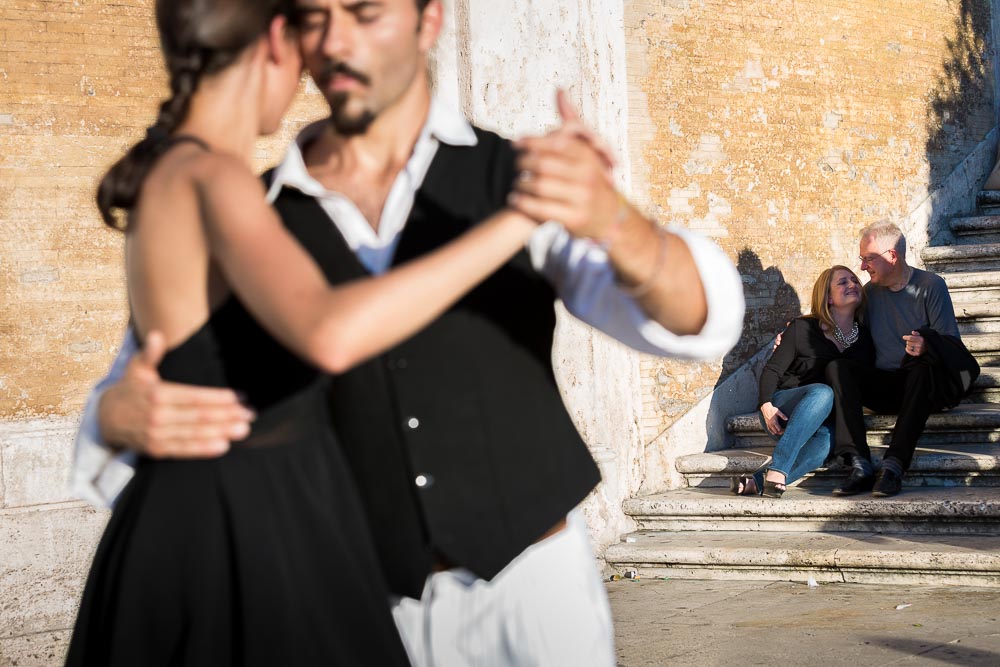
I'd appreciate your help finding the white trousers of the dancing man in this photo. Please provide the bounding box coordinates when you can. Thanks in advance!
[392,511,615,667]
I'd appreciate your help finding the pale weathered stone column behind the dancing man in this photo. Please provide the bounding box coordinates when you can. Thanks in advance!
[433,0,642,551]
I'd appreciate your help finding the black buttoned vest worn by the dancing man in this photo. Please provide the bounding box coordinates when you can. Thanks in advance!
[275,129,600,598]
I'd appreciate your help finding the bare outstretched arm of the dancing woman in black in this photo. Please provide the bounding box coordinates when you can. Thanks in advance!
[195,155,535,373]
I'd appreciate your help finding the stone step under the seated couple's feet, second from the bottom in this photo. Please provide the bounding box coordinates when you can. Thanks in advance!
[622,487,1000,537]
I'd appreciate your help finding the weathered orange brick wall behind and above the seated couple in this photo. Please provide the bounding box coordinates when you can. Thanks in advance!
[626,0,996,442]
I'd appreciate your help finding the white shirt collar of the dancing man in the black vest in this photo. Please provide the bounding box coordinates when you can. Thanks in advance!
[267,97,478,203]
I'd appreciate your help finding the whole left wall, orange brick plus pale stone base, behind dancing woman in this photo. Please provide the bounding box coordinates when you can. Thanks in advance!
[0,0,325,665]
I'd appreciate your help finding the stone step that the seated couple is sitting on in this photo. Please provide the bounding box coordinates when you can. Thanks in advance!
[726,400,1000,449]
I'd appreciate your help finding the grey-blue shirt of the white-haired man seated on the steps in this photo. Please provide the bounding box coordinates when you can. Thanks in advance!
[865,269,960,370]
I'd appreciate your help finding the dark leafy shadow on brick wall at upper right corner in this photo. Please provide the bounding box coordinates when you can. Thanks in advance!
[925,0,996,243]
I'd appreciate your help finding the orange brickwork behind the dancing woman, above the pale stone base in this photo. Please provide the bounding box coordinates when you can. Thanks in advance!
[0,0,324,419]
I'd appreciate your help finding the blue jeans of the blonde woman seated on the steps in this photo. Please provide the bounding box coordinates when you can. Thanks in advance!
[757,384,833,484]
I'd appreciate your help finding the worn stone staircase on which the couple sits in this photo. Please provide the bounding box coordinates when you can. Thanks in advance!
[605,206,1000,587]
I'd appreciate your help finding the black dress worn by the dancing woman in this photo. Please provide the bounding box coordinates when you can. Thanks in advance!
[67,299,408,667]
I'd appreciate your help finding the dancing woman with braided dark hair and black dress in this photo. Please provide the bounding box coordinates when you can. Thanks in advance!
[67,0,534,666]
